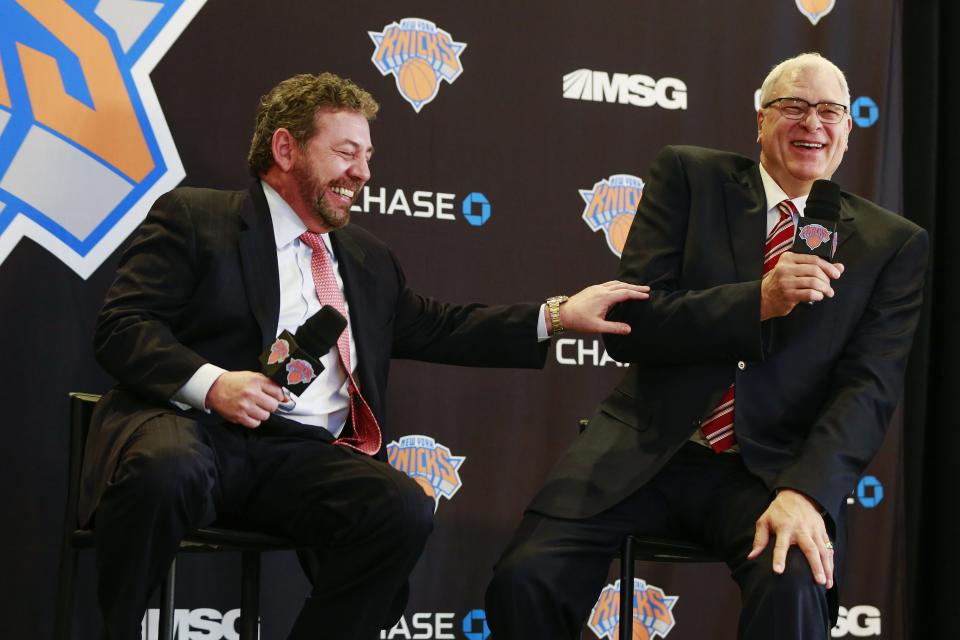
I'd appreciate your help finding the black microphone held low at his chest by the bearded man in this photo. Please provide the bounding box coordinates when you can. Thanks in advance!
[260,305,347,398]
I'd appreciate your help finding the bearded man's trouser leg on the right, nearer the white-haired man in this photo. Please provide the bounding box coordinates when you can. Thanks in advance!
[234,438,434,640]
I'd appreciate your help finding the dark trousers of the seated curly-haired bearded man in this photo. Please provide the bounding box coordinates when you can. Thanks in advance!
[94,414,434,640]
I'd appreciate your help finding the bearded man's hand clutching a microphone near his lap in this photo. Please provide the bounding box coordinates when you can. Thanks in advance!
[206,371,286,429]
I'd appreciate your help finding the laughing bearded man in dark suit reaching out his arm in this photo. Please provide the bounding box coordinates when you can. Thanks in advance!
[80,74,646,640]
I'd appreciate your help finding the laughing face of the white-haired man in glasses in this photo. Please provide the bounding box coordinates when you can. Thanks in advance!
[757,63,853,198]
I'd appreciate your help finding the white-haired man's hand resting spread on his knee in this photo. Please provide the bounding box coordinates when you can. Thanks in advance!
[747,489,833,589]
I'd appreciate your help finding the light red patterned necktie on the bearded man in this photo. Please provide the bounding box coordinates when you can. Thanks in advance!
[300,231,381,456]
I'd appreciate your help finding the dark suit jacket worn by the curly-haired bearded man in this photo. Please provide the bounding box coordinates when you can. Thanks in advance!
[80,182,547,522]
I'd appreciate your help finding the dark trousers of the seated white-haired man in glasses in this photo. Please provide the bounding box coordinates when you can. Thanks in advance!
[486,443,829,640]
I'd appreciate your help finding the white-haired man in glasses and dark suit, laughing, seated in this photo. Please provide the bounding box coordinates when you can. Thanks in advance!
[487,54,927,640]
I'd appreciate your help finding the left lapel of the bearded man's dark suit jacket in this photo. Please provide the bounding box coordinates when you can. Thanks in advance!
[239,182,280,346]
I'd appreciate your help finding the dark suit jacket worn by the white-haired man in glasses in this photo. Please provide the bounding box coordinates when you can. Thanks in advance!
[530,147,928,541]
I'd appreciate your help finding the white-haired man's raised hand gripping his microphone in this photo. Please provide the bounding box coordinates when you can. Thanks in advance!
[760,251,843,321]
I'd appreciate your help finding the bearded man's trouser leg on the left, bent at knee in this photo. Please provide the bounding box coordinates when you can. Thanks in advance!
[94,415,216,640]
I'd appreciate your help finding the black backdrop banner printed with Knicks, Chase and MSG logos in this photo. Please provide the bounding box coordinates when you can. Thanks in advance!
[0,0,904,640]
